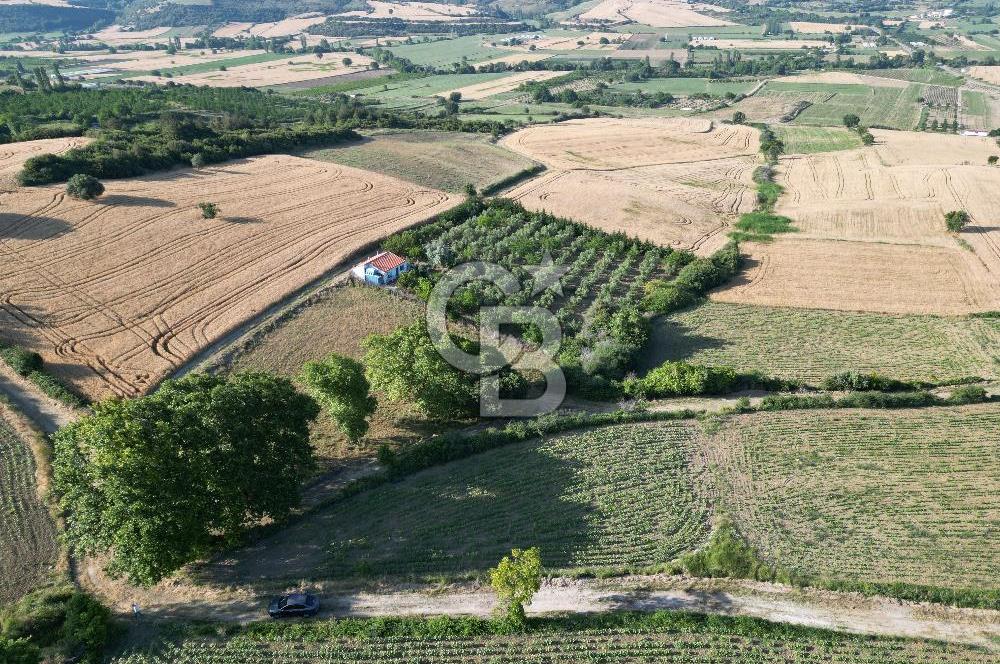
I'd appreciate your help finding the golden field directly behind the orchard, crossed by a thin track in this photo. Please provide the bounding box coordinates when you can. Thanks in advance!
[503,118,758,252]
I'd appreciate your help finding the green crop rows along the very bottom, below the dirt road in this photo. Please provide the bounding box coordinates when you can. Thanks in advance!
[111,612,995,664]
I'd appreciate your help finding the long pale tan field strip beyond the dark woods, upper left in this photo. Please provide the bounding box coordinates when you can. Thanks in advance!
[131,53,371,88]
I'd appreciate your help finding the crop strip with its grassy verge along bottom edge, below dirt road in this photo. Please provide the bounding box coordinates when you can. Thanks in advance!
[112,611,995,664]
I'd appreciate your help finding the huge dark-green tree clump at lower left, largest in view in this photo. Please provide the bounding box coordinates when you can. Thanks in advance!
[53,373,319,584]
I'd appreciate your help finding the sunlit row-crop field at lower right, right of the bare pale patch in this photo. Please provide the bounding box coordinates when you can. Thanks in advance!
[706,404,1000,591]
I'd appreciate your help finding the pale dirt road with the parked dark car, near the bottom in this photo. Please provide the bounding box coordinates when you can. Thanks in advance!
[88,569,1000,651]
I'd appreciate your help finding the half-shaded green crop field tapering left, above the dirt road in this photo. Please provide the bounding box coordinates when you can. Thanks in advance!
[198,422,709,584]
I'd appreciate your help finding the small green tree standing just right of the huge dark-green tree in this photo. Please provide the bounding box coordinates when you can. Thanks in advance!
[299,353,377,442]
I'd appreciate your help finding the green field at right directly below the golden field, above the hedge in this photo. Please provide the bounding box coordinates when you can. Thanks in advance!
[646,302,1000,382]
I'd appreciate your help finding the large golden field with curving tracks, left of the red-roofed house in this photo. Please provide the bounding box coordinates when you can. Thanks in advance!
[0,155,458,397]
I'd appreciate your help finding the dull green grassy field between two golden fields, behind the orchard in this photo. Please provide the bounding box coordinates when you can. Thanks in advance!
[302,130,534,192]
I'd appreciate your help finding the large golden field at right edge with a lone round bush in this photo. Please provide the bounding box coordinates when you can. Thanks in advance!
[714,130,1000,314]
